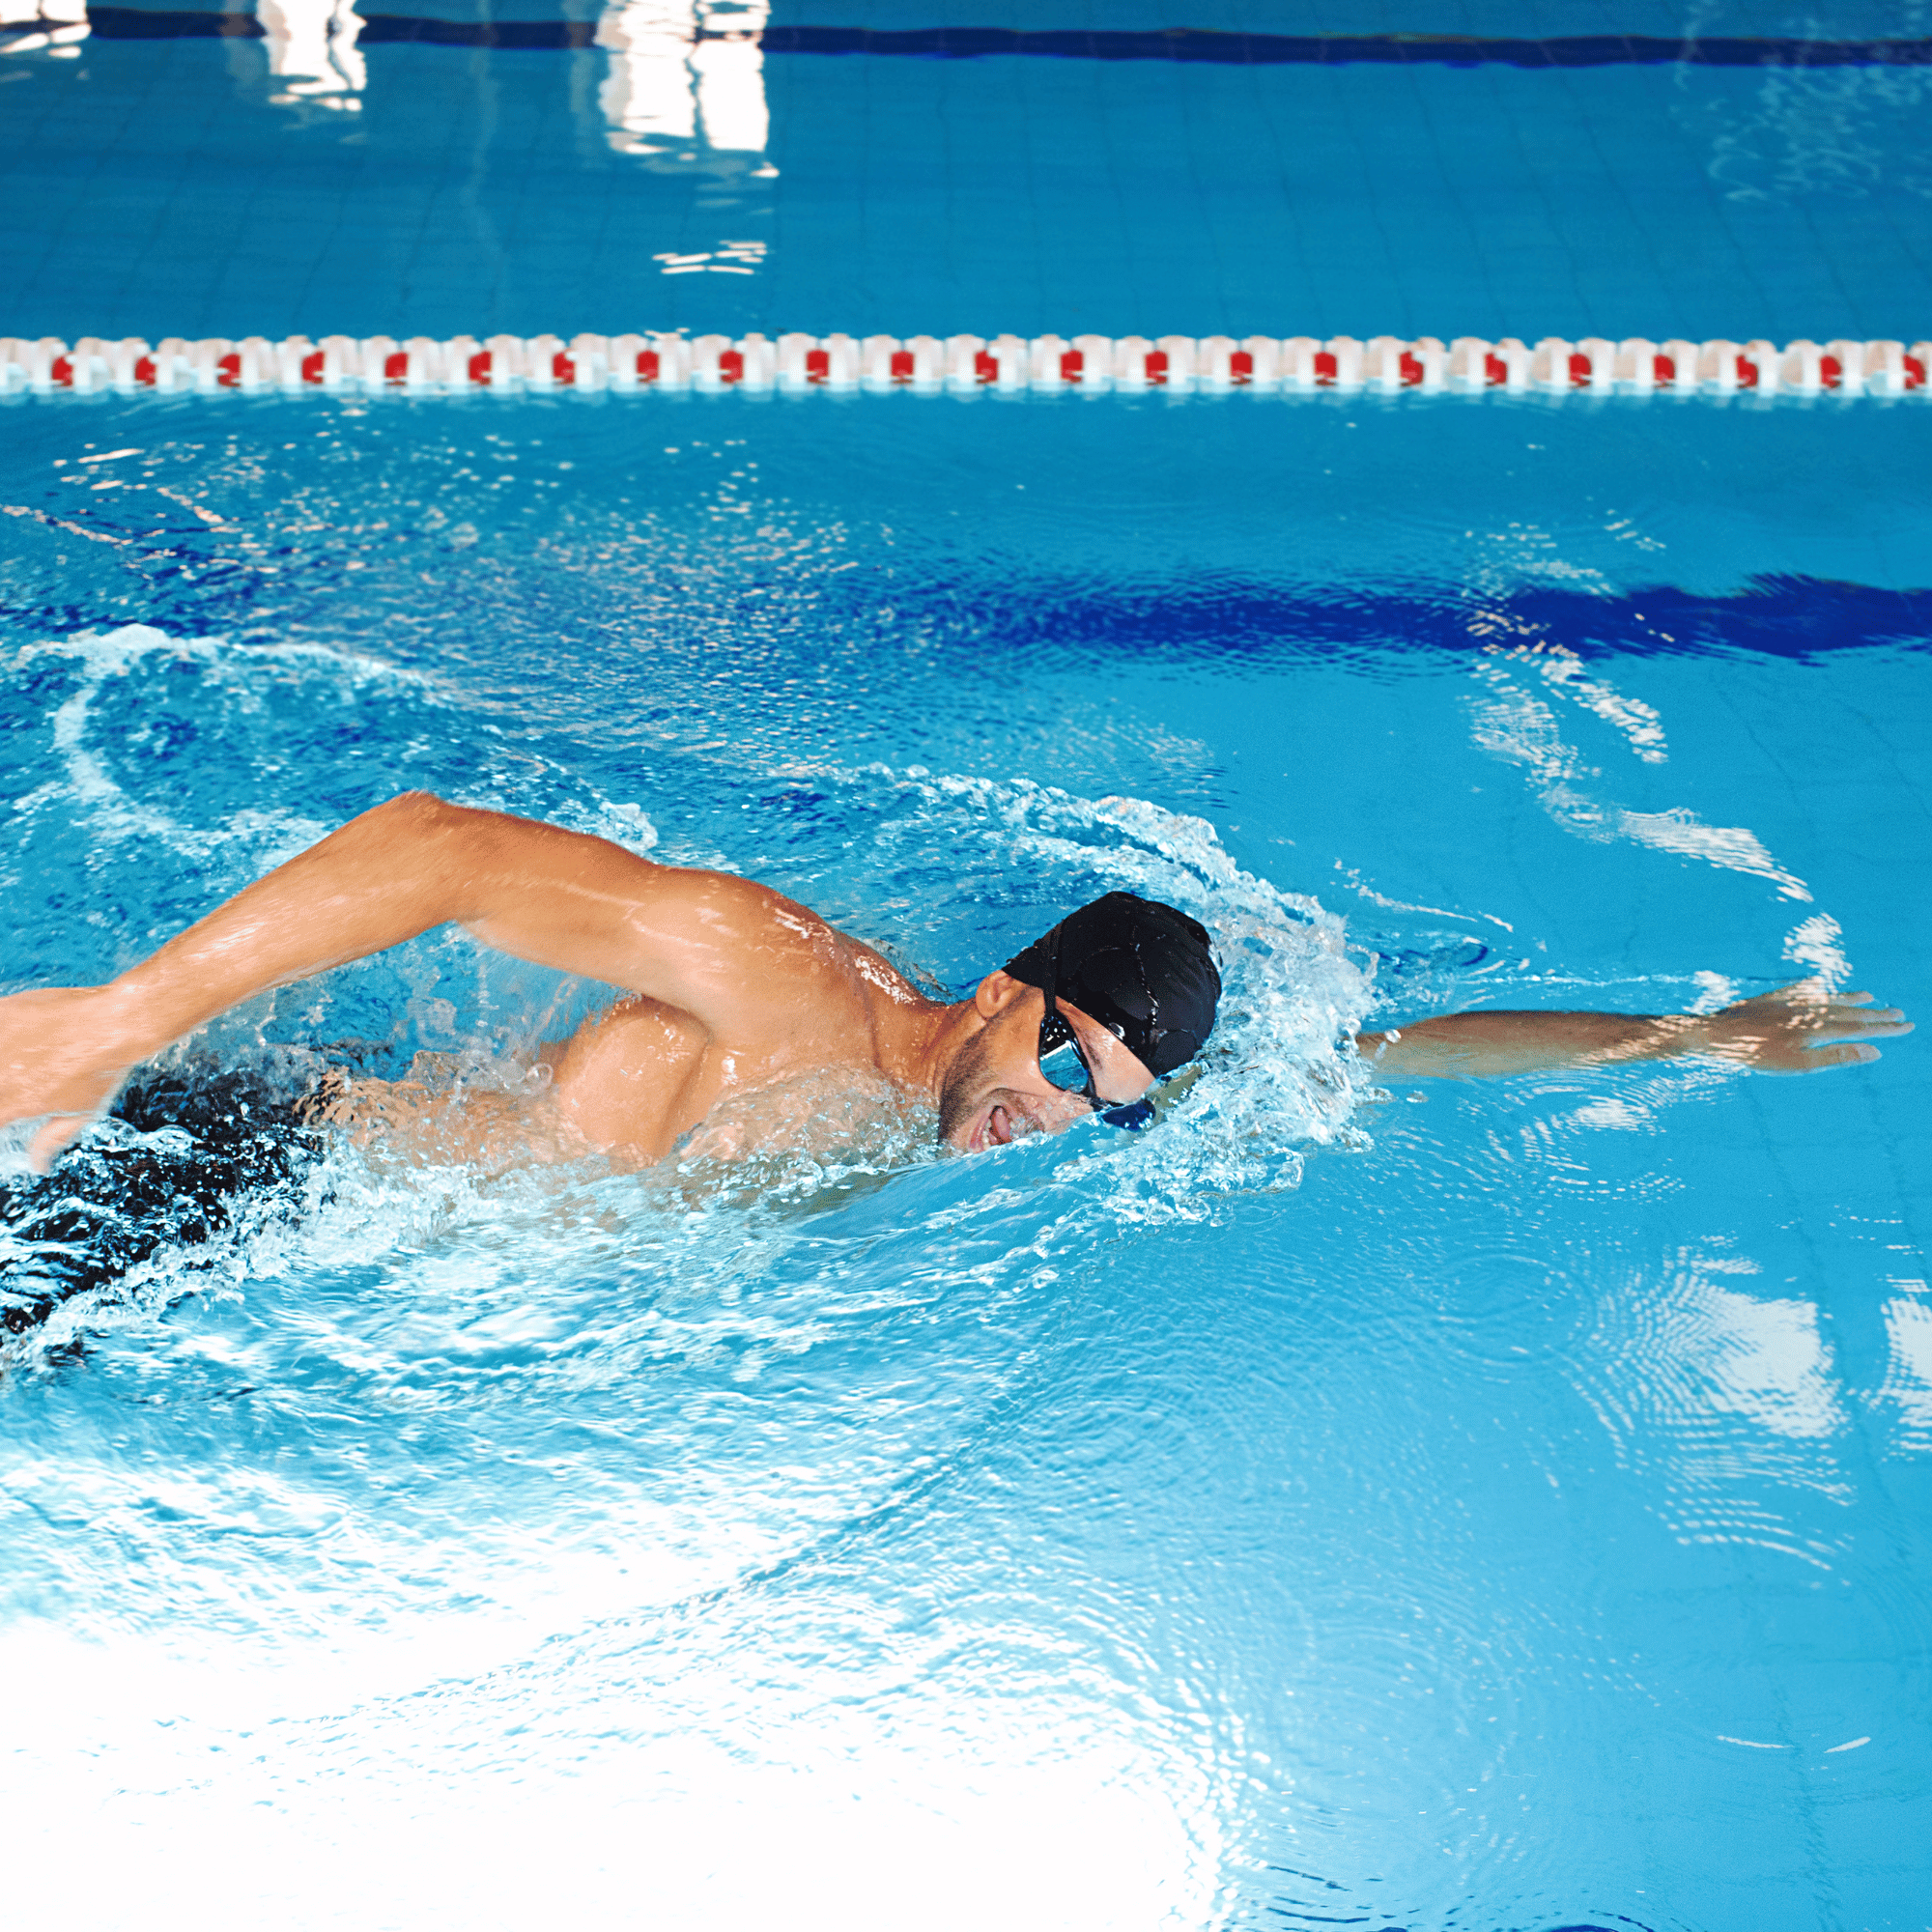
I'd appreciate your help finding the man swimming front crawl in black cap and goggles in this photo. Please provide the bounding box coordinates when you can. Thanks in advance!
[0,792,1909,1173]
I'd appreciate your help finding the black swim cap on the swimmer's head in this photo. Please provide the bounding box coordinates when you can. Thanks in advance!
[1007,893,1221,1074]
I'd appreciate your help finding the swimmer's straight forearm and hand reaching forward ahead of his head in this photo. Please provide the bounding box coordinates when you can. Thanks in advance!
[1356,980,1911,1080]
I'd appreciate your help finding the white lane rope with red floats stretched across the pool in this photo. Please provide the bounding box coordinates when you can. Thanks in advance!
[0,334,1932,396]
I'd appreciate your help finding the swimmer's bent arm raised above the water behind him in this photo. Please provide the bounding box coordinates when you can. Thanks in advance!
[0,792,837,1167]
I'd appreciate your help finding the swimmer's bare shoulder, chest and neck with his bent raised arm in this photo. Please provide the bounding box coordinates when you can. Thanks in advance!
[0,792,970,1169]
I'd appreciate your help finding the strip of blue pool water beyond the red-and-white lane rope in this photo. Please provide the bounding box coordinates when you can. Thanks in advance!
[0,0,1932,342]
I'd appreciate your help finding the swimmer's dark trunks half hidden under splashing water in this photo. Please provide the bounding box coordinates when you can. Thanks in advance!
[0,1066,323,1335]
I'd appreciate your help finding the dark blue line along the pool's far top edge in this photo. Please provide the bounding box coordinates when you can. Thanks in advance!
[34,6,1932,68]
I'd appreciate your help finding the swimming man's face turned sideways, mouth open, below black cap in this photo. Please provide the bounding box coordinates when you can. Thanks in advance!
[939,972,1153,1153]
